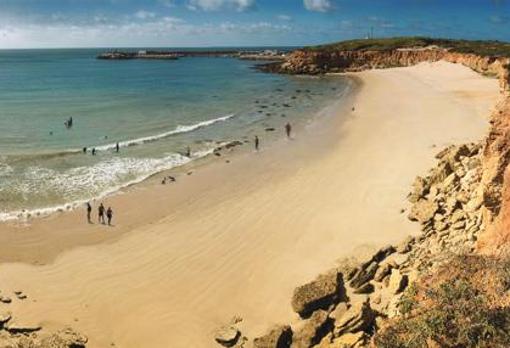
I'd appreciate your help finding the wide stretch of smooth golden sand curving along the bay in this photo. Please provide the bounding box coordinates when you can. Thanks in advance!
[0,63,498,348]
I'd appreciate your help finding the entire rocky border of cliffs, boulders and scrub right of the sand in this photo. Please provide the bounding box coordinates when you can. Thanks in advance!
[217,39,510,348]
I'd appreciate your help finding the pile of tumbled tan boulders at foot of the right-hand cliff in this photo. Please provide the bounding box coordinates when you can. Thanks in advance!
[216,144,485,348]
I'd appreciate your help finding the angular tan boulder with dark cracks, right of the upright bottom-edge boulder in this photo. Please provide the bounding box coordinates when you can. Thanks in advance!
[333,298,376,337]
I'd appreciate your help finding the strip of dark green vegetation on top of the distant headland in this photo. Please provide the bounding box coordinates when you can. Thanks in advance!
[304,36,510,57]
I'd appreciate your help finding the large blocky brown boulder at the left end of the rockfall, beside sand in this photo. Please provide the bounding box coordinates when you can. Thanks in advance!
[292,270,345,318]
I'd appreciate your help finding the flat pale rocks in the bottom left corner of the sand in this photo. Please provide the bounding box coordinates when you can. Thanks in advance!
[0,290,87,348]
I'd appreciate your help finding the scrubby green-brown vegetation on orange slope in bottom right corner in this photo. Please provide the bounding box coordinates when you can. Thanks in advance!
[374,256,510,348]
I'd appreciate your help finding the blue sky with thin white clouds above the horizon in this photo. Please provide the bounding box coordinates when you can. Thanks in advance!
[0,0,510,48]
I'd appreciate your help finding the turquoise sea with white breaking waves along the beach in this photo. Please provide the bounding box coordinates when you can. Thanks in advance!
[0,49,350,220]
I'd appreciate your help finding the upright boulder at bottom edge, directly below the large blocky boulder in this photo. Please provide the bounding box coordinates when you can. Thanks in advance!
[291,309,332,348]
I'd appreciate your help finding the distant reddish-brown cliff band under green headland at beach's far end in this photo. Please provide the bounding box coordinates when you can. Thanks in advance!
[262,48,510,91]
